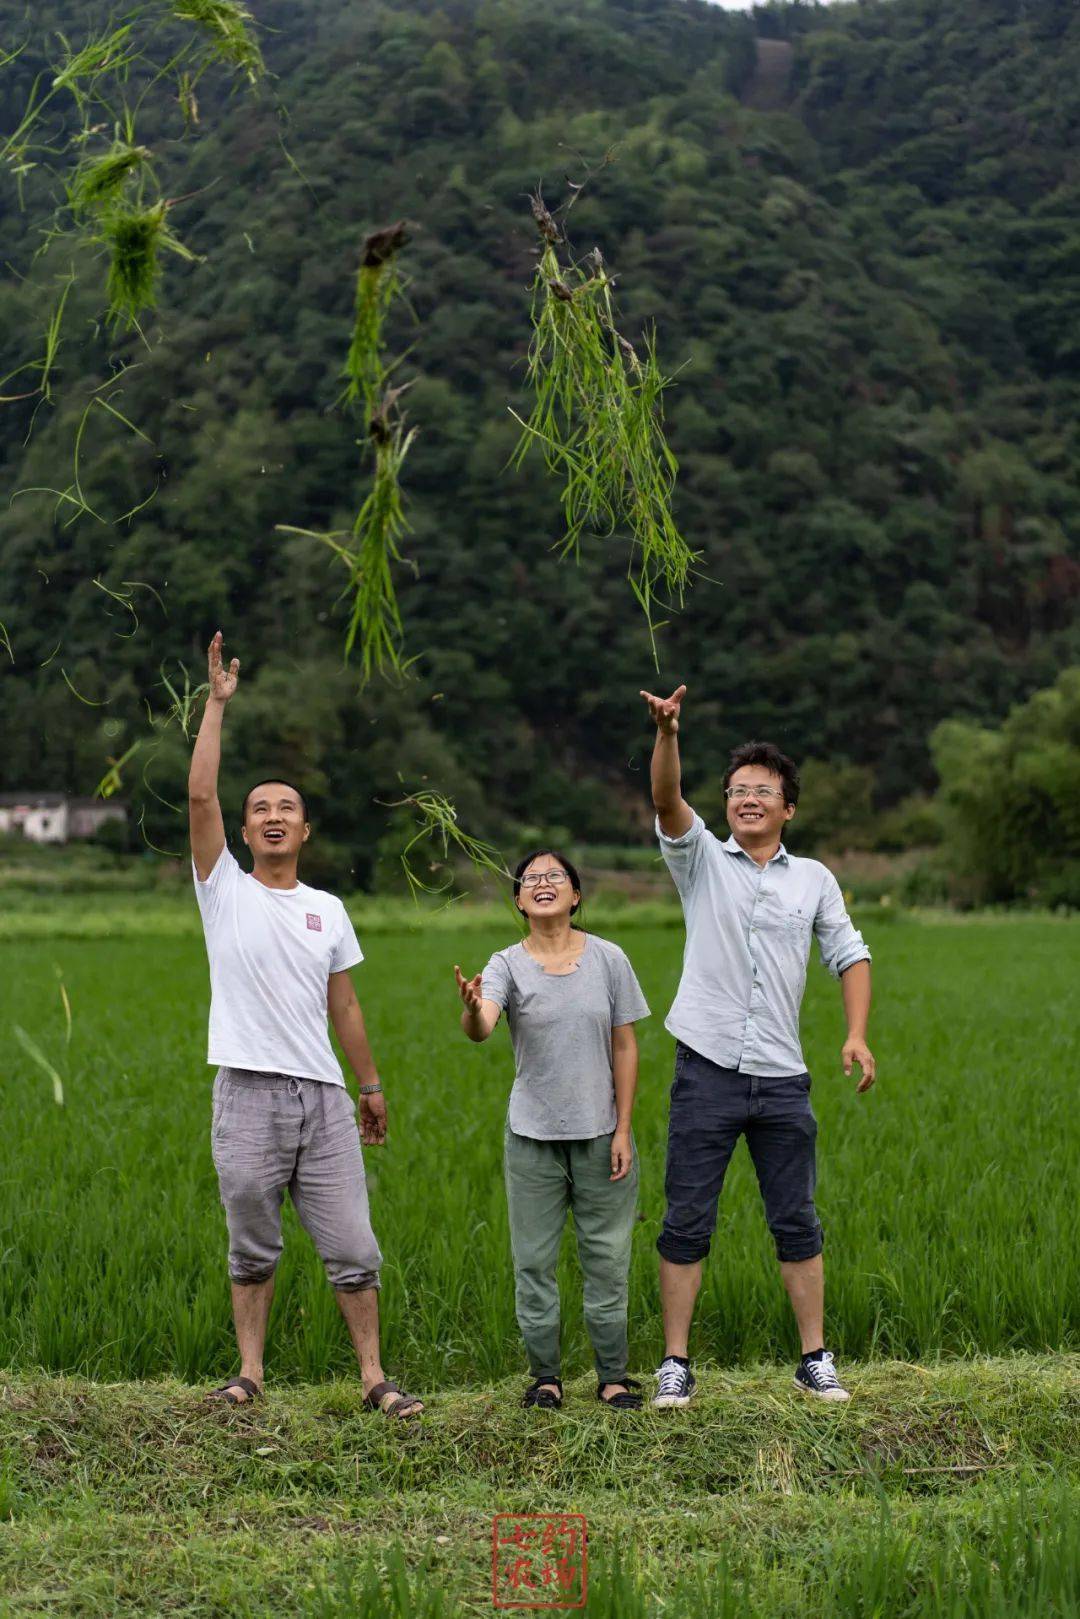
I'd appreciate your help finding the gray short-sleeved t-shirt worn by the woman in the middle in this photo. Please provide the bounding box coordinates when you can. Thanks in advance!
[481,933,649,1141]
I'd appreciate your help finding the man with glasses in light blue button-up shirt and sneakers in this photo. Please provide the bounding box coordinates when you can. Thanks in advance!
[641,686,874,1407]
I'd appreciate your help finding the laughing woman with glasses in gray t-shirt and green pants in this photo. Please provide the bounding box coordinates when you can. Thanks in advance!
[453,850,649,1410]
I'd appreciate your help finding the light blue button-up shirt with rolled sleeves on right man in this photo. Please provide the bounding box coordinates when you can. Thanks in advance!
[656,814,870,1077]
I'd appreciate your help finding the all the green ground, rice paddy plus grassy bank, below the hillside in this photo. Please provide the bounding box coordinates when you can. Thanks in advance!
[0,897,1080,1619]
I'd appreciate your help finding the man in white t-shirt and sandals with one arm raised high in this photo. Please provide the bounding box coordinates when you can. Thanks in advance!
[188,630,424,1417]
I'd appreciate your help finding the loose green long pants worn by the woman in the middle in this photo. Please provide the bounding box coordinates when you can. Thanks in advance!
[504,1125,638,1383]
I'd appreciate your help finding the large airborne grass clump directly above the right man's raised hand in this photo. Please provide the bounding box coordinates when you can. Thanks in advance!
[512,191,695,659]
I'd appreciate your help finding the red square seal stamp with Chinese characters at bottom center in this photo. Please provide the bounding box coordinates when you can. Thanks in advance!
[491,1512,588,1608]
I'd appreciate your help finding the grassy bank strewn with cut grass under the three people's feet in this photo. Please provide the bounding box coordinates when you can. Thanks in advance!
[0,1357,1080,1619]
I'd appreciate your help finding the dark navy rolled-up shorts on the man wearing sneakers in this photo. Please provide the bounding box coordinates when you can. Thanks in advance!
[656,1041,824,1264]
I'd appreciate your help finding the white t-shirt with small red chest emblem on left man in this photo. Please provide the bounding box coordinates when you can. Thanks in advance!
[191,848,364,1086]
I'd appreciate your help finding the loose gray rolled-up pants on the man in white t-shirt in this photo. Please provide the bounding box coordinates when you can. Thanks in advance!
[210,1069,382,1292]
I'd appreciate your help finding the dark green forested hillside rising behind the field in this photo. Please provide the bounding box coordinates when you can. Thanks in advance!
[0,0,1080,881]
